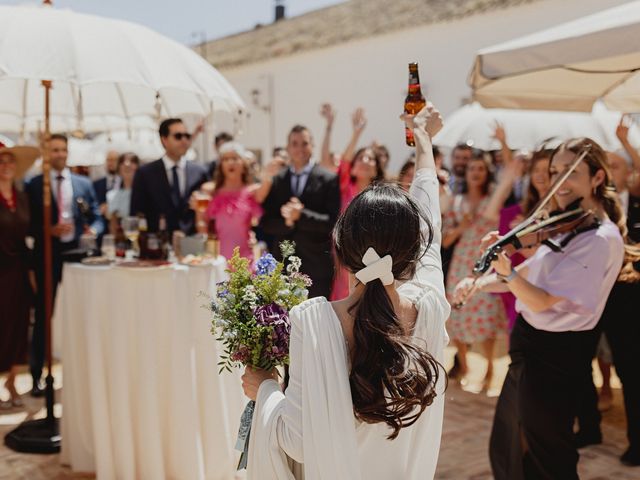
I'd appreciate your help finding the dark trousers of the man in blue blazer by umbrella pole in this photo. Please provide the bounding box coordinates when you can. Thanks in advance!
[29,240,78,385]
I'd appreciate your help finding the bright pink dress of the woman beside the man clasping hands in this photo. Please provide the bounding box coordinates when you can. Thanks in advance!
[207,188,262,259]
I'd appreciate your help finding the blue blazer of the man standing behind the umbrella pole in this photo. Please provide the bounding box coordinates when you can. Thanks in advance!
[26,173,104,251]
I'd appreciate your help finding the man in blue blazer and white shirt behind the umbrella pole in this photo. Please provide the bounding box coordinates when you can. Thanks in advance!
[27,134,104,396]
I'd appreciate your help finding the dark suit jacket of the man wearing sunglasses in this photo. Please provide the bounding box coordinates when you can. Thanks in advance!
[131,159,208,234]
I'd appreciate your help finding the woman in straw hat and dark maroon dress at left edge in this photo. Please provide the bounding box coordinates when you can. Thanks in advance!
[0,143,39,408]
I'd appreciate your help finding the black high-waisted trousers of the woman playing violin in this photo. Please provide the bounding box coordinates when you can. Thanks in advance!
[489,316,599,480]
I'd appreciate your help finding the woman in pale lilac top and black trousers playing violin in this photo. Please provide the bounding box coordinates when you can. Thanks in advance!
[456,138,624,480]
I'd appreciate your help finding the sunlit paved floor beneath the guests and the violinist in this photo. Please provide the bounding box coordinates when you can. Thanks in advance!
[0,349,640,480]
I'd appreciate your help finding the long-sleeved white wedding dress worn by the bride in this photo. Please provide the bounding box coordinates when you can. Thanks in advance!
[247,168,450,480]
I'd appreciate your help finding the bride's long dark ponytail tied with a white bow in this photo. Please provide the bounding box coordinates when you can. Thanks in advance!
[334,183,442,439]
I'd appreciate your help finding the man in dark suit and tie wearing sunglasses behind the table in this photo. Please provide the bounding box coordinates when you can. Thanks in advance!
[131,118,207,234]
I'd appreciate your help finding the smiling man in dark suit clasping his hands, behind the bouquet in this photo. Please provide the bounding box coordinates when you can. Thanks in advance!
[261,125,340,298]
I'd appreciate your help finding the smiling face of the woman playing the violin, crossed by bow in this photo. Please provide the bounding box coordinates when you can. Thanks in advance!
[549,149,606,209]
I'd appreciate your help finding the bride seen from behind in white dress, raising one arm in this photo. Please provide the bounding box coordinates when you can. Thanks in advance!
[243,105,450,480]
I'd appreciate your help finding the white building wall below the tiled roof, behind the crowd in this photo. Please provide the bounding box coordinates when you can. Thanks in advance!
[216,0,625,173]
